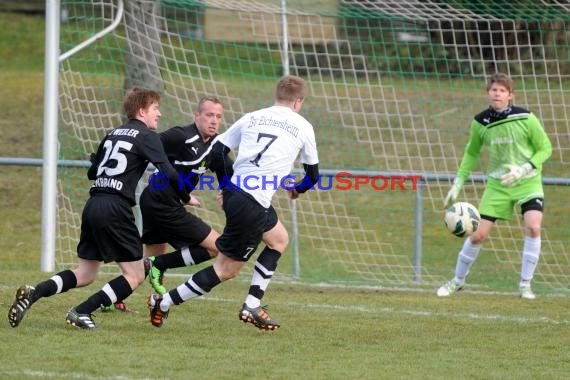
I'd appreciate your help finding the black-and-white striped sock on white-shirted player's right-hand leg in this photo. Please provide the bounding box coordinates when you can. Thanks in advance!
[245,247,281,309]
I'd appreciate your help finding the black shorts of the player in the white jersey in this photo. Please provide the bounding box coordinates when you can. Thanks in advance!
[216,189,277,261]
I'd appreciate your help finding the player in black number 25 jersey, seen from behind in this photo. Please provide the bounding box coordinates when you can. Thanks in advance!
[8,87,190,329]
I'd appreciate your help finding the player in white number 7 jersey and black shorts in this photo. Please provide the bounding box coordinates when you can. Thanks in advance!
[149,75,319,330]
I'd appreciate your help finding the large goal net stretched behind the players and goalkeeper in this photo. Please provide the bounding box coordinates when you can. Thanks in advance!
[56,0,570,292]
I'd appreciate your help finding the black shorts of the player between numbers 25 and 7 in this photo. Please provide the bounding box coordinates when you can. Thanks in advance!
[139,187,212,249]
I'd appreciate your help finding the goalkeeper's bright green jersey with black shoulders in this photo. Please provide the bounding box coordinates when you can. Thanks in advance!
[457,106,552,182]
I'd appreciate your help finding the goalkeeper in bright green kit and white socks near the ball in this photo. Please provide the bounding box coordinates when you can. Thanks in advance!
[437,73,552,299]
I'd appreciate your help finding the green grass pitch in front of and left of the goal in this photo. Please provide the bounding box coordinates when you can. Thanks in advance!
[0,14,570,380]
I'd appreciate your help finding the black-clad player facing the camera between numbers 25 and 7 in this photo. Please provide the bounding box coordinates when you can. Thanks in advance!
[139,96,229,293]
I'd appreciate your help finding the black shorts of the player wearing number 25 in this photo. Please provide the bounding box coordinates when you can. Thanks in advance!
[77,194,143,263]
